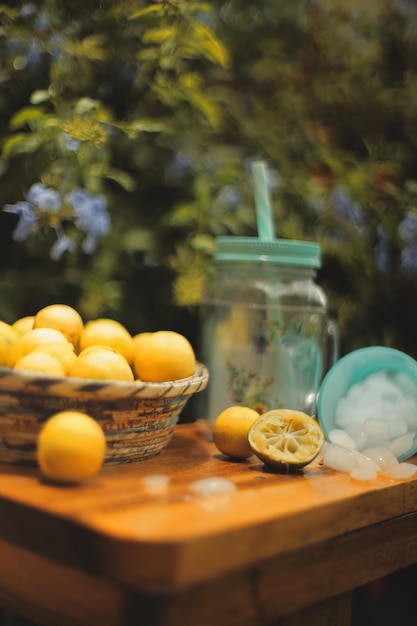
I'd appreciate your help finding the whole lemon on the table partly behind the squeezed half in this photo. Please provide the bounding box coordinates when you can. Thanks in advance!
[213,406,259,459]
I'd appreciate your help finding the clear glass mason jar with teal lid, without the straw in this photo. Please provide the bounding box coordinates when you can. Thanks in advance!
[200,237,338,421]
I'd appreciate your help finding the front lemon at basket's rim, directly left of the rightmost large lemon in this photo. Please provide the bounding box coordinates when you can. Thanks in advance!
[68,348,134,382]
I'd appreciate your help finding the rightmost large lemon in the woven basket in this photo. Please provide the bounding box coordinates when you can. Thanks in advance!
[133,330,196,382]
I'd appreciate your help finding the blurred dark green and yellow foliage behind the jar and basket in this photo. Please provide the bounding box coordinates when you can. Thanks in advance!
[0,0,417,356]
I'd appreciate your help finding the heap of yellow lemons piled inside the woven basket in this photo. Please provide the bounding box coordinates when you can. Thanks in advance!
[0,304,196,382]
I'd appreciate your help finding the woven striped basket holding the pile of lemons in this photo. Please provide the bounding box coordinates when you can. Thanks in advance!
[0,363,209,465]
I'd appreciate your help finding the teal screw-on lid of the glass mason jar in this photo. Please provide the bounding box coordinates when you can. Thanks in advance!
[214,236,321,269]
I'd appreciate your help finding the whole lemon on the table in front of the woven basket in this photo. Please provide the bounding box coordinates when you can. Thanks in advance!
[37,411,106,483]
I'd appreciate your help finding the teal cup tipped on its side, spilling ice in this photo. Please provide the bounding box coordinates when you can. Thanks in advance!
[317,346,417,461]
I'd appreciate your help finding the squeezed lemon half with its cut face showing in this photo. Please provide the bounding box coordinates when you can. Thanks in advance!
[248,409,325,470]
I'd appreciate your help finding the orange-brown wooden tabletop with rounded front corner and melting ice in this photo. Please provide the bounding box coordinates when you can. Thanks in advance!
[0,424,417,589]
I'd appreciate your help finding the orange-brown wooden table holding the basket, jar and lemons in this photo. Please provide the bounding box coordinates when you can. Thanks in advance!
[0,422,417,626]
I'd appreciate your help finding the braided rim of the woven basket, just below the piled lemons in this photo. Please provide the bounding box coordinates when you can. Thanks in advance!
[0,361,209,398]
